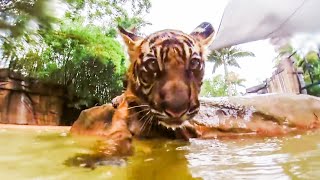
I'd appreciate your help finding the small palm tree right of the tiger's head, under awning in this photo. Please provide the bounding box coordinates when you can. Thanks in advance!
[208,46,255,96]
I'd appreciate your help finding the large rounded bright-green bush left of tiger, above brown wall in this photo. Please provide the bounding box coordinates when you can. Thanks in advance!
[7,24,125,108]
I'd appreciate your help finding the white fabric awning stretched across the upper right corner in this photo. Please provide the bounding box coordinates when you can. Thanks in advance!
[210,0,320,49]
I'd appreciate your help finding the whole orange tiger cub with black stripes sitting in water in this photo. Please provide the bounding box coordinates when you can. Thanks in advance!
[71,22,214,154]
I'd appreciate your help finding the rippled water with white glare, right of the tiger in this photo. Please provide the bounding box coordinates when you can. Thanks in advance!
[184,136,320,179]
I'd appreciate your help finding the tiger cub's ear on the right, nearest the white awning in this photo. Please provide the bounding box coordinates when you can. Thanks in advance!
[190,22,215,46]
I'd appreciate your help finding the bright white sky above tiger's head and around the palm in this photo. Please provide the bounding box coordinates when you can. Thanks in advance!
[141,0,276,87]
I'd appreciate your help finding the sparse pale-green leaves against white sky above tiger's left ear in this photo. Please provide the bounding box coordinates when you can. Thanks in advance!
[66,0,151,37]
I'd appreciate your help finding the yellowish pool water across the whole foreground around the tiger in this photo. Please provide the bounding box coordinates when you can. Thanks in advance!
[0,128,320,180]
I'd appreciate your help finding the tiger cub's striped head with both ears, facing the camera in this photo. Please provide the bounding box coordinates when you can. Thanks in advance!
[119,23,214,128]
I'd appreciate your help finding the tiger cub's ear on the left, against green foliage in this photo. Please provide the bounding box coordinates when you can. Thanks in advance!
[118,26,143,59]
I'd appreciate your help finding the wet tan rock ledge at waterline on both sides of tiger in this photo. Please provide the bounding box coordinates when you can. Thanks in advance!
[71,94,320,138]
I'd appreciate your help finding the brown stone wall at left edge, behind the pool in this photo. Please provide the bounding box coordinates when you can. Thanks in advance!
[0,69,65,125]
